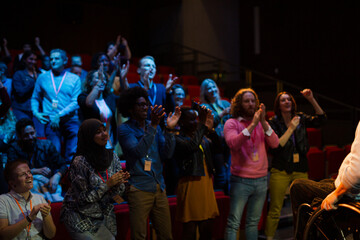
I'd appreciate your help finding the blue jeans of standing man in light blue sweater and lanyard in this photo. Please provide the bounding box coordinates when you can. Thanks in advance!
[45,117,80,163]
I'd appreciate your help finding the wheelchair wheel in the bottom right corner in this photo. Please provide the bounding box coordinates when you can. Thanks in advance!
[303,203,360,240]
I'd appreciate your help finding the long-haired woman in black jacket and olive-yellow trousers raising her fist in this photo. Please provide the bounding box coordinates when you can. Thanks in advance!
[265,89,326,239]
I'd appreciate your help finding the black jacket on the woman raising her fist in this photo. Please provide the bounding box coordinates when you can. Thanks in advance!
[269,113,326,173]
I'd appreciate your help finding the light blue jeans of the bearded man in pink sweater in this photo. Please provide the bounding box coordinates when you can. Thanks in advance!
[225,175,267,240]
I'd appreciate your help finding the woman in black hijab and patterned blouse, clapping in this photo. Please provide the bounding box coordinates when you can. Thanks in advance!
[61,119,129,239]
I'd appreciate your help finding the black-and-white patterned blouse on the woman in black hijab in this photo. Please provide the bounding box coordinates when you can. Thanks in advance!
[60,154,125,236]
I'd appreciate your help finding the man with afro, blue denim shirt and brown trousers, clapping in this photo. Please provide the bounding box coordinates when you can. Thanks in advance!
[118,87,181,239]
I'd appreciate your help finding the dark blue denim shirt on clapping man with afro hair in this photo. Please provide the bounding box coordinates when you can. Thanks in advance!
[118,119,175,192]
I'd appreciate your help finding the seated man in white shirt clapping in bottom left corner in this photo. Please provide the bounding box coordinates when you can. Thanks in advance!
[0,160,56,240]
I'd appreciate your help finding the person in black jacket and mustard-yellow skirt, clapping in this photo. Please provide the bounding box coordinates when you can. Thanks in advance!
[174,106,221,239]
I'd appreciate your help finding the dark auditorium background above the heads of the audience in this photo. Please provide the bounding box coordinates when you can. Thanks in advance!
[0,0,360,142]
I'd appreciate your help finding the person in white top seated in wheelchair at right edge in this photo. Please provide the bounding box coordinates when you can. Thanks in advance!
[290,122,360,239]
